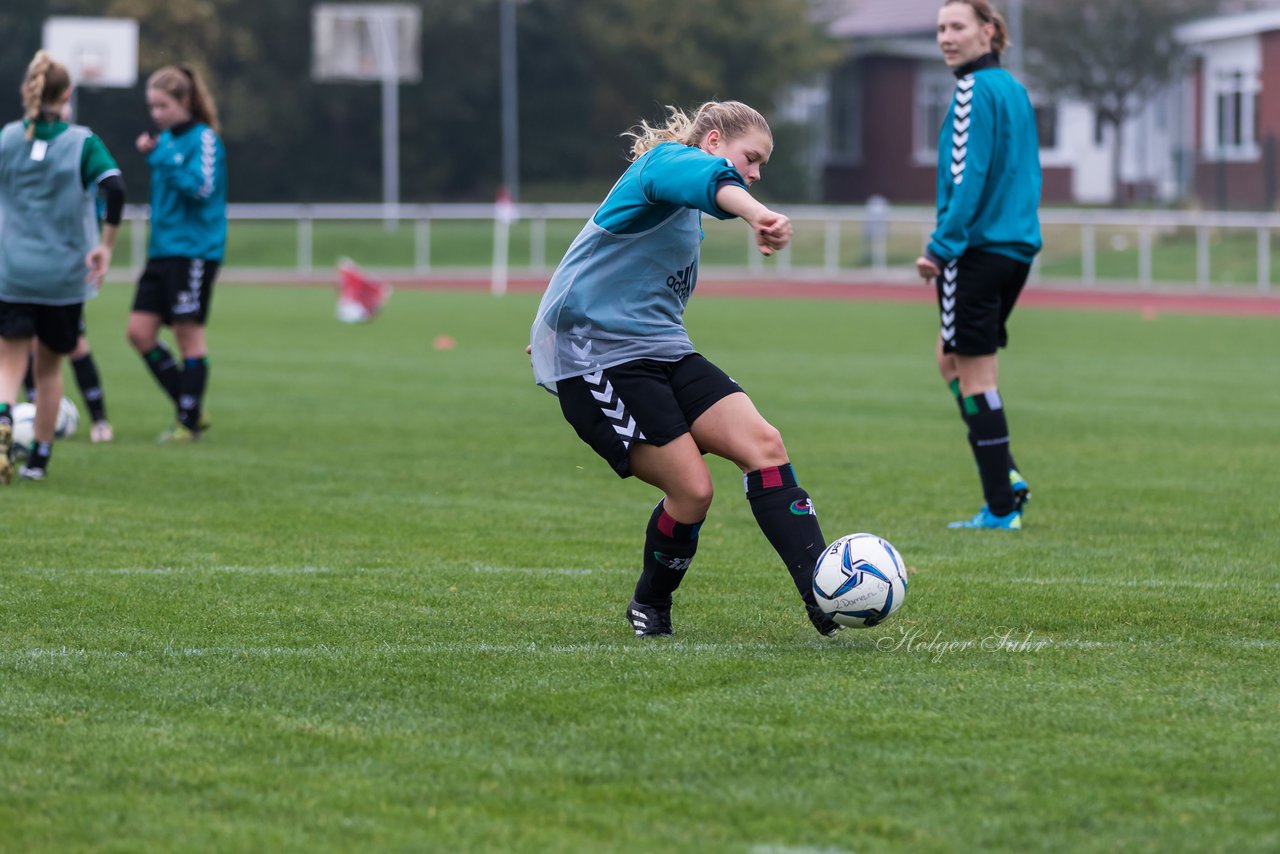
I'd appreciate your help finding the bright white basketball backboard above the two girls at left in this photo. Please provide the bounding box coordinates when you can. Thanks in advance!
[42,17,138,88]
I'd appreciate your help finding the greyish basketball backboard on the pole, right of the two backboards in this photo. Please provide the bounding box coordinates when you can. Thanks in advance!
[311,3,422,82]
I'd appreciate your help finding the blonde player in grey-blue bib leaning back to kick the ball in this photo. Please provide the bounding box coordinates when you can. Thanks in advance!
[530,101,837,636]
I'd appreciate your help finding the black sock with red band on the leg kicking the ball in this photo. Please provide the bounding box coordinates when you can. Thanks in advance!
[742,462,827,611]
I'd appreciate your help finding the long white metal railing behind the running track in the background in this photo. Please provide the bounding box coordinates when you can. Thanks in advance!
[124,204,1280,293]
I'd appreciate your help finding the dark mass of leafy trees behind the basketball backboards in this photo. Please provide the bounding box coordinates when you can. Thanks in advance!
[0,0,833,201]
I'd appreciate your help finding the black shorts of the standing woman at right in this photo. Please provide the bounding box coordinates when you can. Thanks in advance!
[937,250,1032,356]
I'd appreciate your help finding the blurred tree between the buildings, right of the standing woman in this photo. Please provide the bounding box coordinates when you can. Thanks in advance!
[1025,0,1217,202]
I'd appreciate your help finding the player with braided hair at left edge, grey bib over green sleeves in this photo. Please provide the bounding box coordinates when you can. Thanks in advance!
[0,51,124,483]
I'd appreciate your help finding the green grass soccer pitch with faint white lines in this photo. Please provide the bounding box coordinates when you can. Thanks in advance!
[0,286,1280,854]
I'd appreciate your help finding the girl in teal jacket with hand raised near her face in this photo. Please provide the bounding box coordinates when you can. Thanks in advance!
[128,65,227,442]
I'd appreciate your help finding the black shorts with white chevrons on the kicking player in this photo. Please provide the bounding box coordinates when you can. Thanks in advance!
[556,353,742,478]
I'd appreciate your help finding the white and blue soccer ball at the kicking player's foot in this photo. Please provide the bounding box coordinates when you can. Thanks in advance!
[813,534,906,629]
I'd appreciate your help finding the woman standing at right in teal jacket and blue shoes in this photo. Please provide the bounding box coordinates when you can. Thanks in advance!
[915,0,1041,530]
